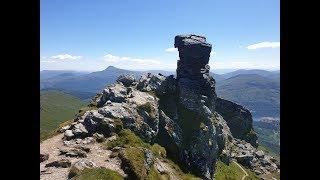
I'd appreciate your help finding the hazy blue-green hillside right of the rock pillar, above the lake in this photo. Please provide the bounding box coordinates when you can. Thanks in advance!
[216,74,280,117]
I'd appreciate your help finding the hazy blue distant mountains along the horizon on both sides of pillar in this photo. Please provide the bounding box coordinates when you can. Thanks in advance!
[40,66,280,117]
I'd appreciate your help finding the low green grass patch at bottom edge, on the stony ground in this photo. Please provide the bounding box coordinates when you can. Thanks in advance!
[73,167,124,180]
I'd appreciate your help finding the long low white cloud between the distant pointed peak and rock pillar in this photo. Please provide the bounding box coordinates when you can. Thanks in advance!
[103,54,176,69]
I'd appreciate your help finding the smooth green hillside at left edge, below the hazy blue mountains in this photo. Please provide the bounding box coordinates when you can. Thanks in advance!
[40,90,85,139]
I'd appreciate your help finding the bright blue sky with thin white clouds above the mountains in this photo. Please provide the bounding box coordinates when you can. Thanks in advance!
[40,0,280,71]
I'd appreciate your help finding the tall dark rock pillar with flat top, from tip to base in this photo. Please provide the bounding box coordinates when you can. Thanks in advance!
[174,35,218,179]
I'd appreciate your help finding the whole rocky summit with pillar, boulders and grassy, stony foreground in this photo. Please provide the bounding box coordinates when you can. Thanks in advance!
[40,35,280,180]
